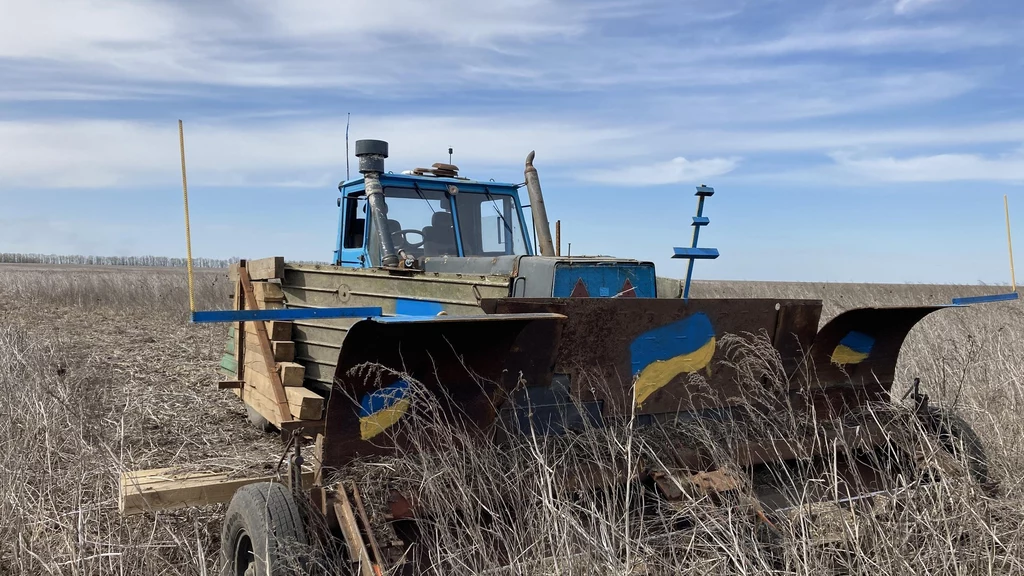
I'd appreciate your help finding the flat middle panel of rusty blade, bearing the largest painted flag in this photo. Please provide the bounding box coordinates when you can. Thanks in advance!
[481,298,821,417]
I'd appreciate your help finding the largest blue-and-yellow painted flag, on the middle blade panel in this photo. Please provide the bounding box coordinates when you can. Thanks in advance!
[630,313,715,406]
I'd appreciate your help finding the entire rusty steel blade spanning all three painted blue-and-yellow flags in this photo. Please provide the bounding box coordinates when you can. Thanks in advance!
[325,298,941,469]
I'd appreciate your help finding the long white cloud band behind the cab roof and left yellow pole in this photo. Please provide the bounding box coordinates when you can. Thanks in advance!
[0,116,643,189]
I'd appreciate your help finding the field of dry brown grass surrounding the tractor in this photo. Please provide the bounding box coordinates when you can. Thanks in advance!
[0,265,1024,576]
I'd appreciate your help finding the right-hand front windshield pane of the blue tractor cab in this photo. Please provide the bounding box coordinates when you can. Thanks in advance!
[455,193,526,256]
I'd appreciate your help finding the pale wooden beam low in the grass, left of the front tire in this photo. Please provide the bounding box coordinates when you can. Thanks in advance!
[118,468,313,516]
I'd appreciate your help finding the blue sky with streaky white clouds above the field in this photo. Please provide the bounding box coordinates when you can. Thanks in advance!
[0,0,1024,283]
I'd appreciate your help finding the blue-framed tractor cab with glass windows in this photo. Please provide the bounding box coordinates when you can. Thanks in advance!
[335,164,534,268]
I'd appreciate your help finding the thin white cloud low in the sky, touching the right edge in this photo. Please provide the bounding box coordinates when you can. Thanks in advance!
[831,149,1024,183]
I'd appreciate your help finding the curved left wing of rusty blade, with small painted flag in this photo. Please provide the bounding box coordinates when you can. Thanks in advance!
[324,314,564,467]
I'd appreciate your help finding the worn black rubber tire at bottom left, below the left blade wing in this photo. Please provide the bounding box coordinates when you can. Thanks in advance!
[220,483,308,576]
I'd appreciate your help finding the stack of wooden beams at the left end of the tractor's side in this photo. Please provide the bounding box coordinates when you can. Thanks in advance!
[220,257,325,428]
